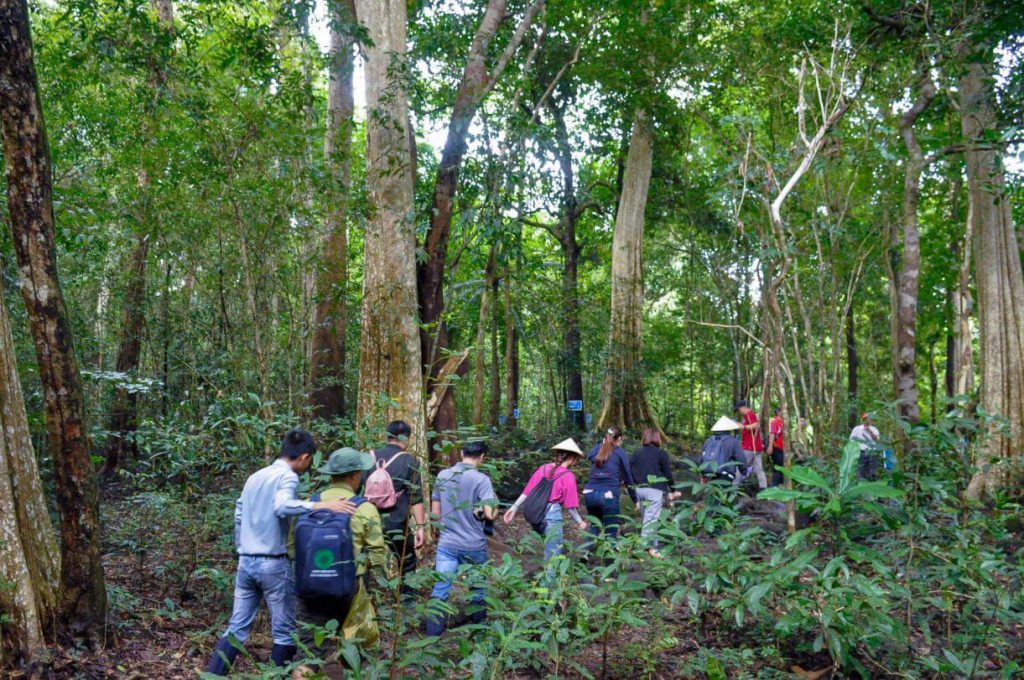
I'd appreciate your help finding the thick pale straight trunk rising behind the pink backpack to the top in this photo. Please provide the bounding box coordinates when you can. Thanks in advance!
[355,0,428,465]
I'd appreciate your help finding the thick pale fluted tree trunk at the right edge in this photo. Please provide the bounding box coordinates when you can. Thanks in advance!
[959,46,1024,498]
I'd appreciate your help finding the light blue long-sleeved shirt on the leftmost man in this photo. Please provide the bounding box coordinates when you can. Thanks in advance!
[234,459,313,555]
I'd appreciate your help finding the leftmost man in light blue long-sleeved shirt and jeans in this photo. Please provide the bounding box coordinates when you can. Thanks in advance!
[206,429,355,675]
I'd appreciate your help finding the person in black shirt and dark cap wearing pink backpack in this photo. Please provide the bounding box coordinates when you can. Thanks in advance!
[374,420,427,593]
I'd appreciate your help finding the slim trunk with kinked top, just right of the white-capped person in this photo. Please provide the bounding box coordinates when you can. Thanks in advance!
[893,69,936,425]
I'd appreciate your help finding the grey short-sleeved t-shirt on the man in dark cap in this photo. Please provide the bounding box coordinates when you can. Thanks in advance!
[430,463,498,551]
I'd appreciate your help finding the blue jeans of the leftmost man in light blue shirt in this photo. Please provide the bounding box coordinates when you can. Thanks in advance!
[222,555,296,645]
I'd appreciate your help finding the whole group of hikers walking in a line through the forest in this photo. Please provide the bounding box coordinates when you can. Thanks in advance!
[206,401,879,678]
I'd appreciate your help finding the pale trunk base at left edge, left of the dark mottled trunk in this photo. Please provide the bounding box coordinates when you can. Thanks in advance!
[0,282,60,663]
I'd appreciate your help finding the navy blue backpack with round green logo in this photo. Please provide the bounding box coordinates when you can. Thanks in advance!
[295,494,366,599]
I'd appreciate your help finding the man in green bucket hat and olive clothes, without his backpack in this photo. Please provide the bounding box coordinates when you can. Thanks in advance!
[296,448,395,677]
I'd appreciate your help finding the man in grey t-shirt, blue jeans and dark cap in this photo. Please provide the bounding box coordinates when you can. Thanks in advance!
[426,441,498,636]
